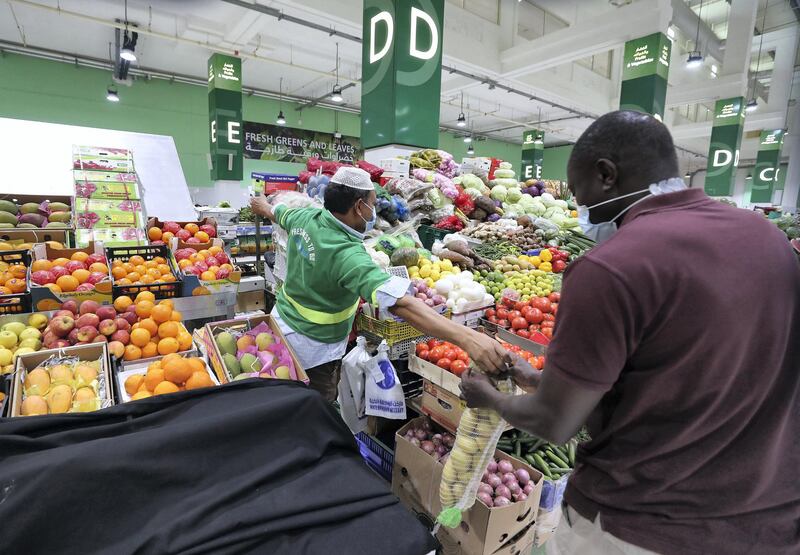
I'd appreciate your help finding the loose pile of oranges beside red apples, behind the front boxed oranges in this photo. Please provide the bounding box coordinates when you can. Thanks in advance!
[114,291,192,360]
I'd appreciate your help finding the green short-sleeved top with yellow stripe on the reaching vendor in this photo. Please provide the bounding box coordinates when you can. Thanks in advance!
[275,205,389,343]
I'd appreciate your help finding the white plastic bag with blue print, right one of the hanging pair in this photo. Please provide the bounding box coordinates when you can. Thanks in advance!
[365,341,406,420]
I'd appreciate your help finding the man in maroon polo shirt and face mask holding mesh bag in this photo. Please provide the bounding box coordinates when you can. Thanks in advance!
[462,112,800,555]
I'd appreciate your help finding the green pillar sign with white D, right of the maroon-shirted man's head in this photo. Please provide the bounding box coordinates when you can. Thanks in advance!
[705,96,744,197]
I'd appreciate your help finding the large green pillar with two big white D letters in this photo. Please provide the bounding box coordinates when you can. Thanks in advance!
[361,0,444,148]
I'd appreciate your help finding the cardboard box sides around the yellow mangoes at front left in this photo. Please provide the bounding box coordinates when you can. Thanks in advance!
[9,343,115,416]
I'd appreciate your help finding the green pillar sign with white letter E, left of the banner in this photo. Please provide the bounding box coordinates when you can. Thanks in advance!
[208,54,243,181]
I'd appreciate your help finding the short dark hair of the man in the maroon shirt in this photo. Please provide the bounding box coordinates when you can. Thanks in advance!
[570,110,678,175]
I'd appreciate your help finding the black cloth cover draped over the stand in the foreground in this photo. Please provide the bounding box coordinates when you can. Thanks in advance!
[0,380,434,555]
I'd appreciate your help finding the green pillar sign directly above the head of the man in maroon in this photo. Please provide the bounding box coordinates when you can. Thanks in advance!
[619,33,672,120]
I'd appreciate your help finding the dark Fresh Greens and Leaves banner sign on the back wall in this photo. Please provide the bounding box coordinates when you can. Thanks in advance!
[244,121,364,164]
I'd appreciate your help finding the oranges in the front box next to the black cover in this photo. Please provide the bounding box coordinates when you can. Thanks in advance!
[125,353,215,401]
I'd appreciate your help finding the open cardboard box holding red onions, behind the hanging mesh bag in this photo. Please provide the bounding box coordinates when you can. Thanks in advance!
[392,418,543,555]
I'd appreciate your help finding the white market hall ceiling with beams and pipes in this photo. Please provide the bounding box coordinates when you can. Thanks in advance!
[0,0,798,165]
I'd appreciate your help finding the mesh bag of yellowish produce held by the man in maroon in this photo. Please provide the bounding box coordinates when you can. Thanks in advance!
[436,367,514,528]
